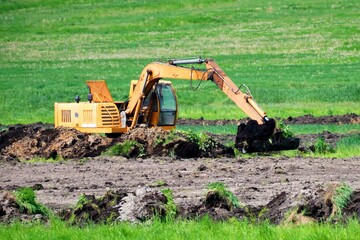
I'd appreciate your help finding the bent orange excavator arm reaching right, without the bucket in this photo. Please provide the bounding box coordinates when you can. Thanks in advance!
[125,58,268,124]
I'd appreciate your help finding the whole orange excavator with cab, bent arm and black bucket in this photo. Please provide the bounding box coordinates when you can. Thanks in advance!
[54,57,298,152]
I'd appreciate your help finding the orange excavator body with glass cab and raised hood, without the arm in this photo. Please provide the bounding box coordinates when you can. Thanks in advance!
[54,80,178,134]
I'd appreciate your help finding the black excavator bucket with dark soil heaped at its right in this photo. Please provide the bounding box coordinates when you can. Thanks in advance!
[235,119,300,153]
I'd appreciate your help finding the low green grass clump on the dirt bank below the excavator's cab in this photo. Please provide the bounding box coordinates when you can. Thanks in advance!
[103,140,145,158]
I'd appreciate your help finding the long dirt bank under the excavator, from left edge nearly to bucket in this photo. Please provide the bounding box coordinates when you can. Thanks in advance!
[0,124,234,161]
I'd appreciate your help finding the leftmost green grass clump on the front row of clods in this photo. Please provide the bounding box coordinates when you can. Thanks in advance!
[15,187,50,216]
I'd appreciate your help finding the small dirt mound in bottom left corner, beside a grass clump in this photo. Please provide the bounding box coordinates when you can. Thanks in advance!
[0,191,48,223]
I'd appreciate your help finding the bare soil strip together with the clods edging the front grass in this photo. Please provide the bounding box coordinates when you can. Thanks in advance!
[0,157,360,224]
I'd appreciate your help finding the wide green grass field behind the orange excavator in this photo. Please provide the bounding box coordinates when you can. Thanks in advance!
[0,0,360,124]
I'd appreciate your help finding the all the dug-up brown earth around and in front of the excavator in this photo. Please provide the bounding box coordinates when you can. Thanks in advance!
[0,114,360,224]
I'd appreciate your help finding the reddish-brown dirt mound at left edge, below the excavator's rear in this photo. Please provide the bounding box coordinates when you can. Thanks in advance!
[0,125,112,160]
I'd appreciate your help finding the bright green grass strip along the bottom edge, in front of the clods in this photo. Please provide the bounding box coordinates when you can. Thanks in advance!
[0,218,360,240]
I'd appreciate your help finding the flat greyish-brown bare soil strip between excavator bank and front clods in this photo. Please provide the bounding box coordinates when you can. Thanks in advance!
[0,157,360,222]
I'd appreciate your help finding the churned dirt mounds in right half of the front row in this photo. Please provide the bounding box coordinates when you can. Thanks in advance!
[180,184,360,224]
